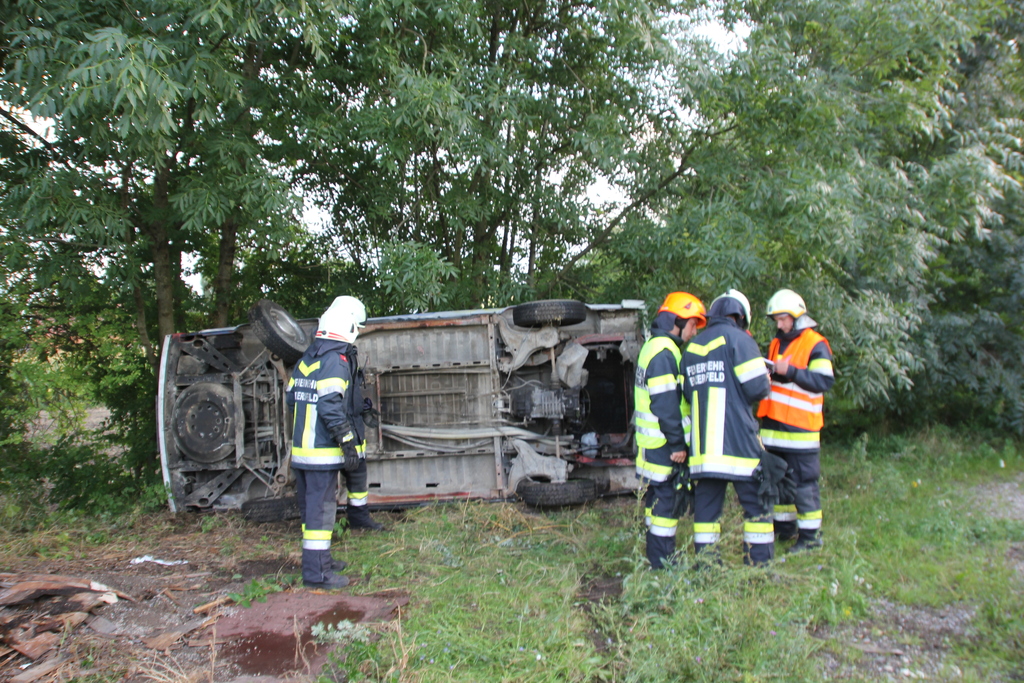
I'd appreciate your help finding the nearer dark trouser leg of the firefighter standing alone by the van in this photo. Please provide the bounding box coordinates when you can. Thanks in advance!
[293,469,338,584]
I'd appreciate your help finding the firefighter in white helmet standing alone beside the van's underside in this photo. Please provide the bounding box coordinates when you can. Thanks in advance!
[285,296,379,590]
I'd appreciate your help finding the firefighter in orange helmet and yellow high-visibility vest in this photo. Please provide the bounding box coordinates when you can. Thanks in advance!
[633,292,707,569]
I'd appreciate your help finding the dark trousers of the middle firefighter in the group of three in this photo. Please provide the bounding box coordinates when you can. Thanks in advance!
[693,479,775,564]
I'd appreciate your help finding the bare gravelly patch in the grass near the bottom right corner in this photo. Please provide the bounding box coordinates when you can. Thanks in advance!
[812,599,975,681]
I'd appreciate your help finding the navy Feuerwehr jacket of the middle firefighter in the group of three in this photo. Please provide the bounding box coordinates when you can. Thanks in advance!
[683,316,771,480]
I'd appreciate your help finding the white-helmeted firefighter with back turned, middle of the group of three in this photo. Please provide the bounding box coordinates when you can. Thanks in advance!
[683,290,775,564]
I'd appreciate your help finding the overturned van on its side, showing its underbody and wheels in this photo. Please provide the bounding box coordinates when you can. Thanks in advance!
[158,300,643,519]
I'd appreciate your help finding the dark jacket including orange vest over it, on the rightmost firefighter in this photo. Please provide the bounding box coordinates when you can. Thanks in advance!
[758,328,836,453]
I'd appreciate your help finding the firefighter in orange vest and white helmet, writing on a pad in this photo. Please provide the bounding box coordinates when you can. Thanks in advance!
[758,290,836,552]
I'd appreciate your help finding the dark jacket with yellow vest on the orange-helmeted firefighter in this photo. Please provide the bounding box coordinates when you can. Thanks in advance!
[633,329,690,481]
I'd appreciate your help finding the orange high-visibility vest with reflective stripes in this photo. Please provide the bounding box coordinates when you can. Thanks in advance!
[758,330,831,431]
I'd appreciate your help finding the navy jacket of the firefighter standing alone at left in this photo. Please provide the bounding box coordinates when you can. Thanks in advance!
[285,338,366,470]
